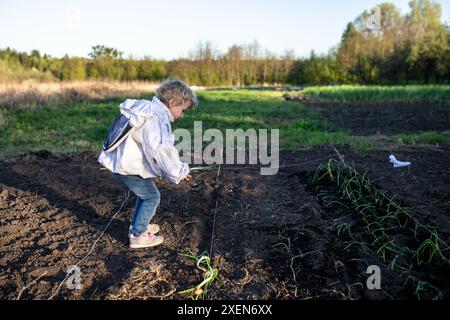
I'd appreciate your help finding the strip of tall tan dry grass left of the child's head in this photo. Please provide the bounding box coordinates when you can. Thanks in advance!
[0,80,162,109]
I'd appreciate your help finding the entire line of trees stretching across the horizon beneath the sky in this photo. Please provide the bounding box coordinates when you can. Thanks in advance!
[0,0,450,86]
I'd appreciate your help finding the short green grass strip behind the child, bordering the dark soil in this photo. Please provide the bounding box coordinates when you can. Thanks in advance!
[0,90,449,157]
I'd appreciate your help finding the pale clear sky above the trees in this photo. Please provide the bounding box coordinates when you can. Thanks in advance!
[0,0,450,59]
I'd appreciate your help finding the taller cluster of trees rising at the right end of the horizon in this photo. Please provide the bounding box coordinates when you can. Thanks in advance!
[289,0,450,84]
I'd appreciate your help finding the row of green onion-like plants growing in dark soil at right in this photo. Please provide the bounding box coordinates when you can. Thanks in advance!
[309,160,450,299]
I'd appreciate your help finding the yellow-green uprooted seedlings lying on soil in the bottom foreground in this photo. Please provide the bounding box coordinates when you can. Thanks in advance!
[179,252,219,300]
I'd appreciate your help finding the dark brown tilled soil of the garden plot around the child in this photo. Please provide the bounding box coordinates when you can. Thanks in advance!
[0,148,450,299]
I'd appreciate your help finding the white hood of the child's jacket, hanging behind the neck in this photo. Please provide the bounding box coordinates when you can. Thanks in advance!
[119,97,174,127]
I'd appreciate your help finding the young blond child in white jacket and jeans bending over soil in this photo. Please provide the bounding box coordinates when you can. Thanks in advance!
[98,79,198,249]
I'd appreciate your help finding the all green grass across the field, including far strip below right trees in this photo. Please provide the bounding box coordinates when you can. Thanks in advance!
[0,82,450,157]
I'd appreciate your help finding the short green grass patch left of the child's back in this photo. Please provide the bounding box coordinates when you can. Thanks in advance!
[0,100,120,156]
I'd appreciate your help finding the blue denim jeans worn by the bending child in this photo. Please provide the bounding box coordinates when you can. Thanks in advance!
[113,173,161,237]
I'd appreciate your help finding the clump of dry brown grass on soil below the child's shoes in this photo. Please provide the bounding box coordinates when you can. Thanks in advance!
[105,262,176,300]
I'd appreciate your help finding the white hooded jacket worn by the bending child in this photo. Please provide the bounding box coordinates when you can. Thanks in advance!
[98,97,189,184]
